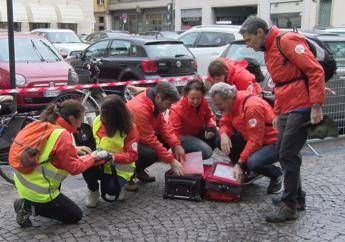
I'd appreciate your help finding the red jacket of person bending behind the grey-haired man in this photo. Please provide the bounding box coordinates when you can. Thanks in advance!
[210,58,262,94]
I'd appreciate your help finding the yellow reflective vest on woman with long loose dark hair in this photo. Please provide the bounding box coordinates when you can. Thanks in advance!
[92,116,135,181]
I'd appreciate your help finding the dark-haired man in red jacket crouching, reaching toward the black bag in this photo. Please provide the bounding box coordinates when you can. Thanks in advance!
[127,82,185,182]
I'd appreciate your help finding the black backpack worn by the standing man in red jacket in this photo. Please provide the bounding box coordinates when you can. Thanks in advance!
[276,31,337,82]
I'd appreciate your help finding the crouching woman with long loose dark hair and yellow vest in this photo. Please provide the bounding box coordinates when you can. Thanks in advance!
[83,95,138,208]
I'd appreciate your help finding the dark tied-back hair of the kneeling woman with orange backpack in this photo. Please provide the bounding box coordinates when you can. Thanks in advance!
[40,99,85,124]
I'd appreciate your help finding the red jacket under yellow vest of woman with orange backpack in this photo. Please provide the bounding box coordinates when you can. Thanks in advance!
[51,118,94,175]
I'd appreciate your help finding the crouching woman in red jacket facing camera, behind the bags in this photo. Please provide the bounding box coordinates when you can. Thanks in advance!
[169,80,218,160]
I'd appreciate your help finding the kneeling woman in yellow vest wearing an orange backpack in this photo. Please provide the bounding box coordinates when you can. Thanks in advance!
[9,100,104,227]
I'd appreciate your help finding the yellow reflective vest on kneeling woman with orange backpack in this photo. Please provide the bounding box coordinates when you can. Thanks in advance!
[14,129,68,203]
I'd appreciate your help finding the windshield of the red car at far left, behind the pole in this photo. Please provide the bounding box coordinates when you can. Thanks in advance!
[0,38,61,62]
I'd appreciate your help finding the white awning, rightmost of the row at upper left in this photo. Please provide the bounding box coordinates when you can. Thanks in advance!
[56,4,86,23]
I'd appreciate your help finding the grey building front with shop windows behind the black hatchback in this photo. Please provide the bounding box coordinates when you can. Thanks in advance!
[108,0,175,33]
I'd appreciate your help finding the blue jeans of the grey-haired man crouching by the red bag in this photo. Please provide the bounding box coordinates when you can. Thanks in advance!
[247,145,283,179]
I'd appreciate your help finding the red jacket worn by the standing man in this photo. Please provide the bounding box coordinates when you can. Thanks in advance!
[264,26,325,114]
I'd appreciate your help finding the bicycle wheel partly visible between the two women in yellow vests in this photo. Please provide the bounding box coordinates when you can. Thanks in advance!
[52,91,101,125]
